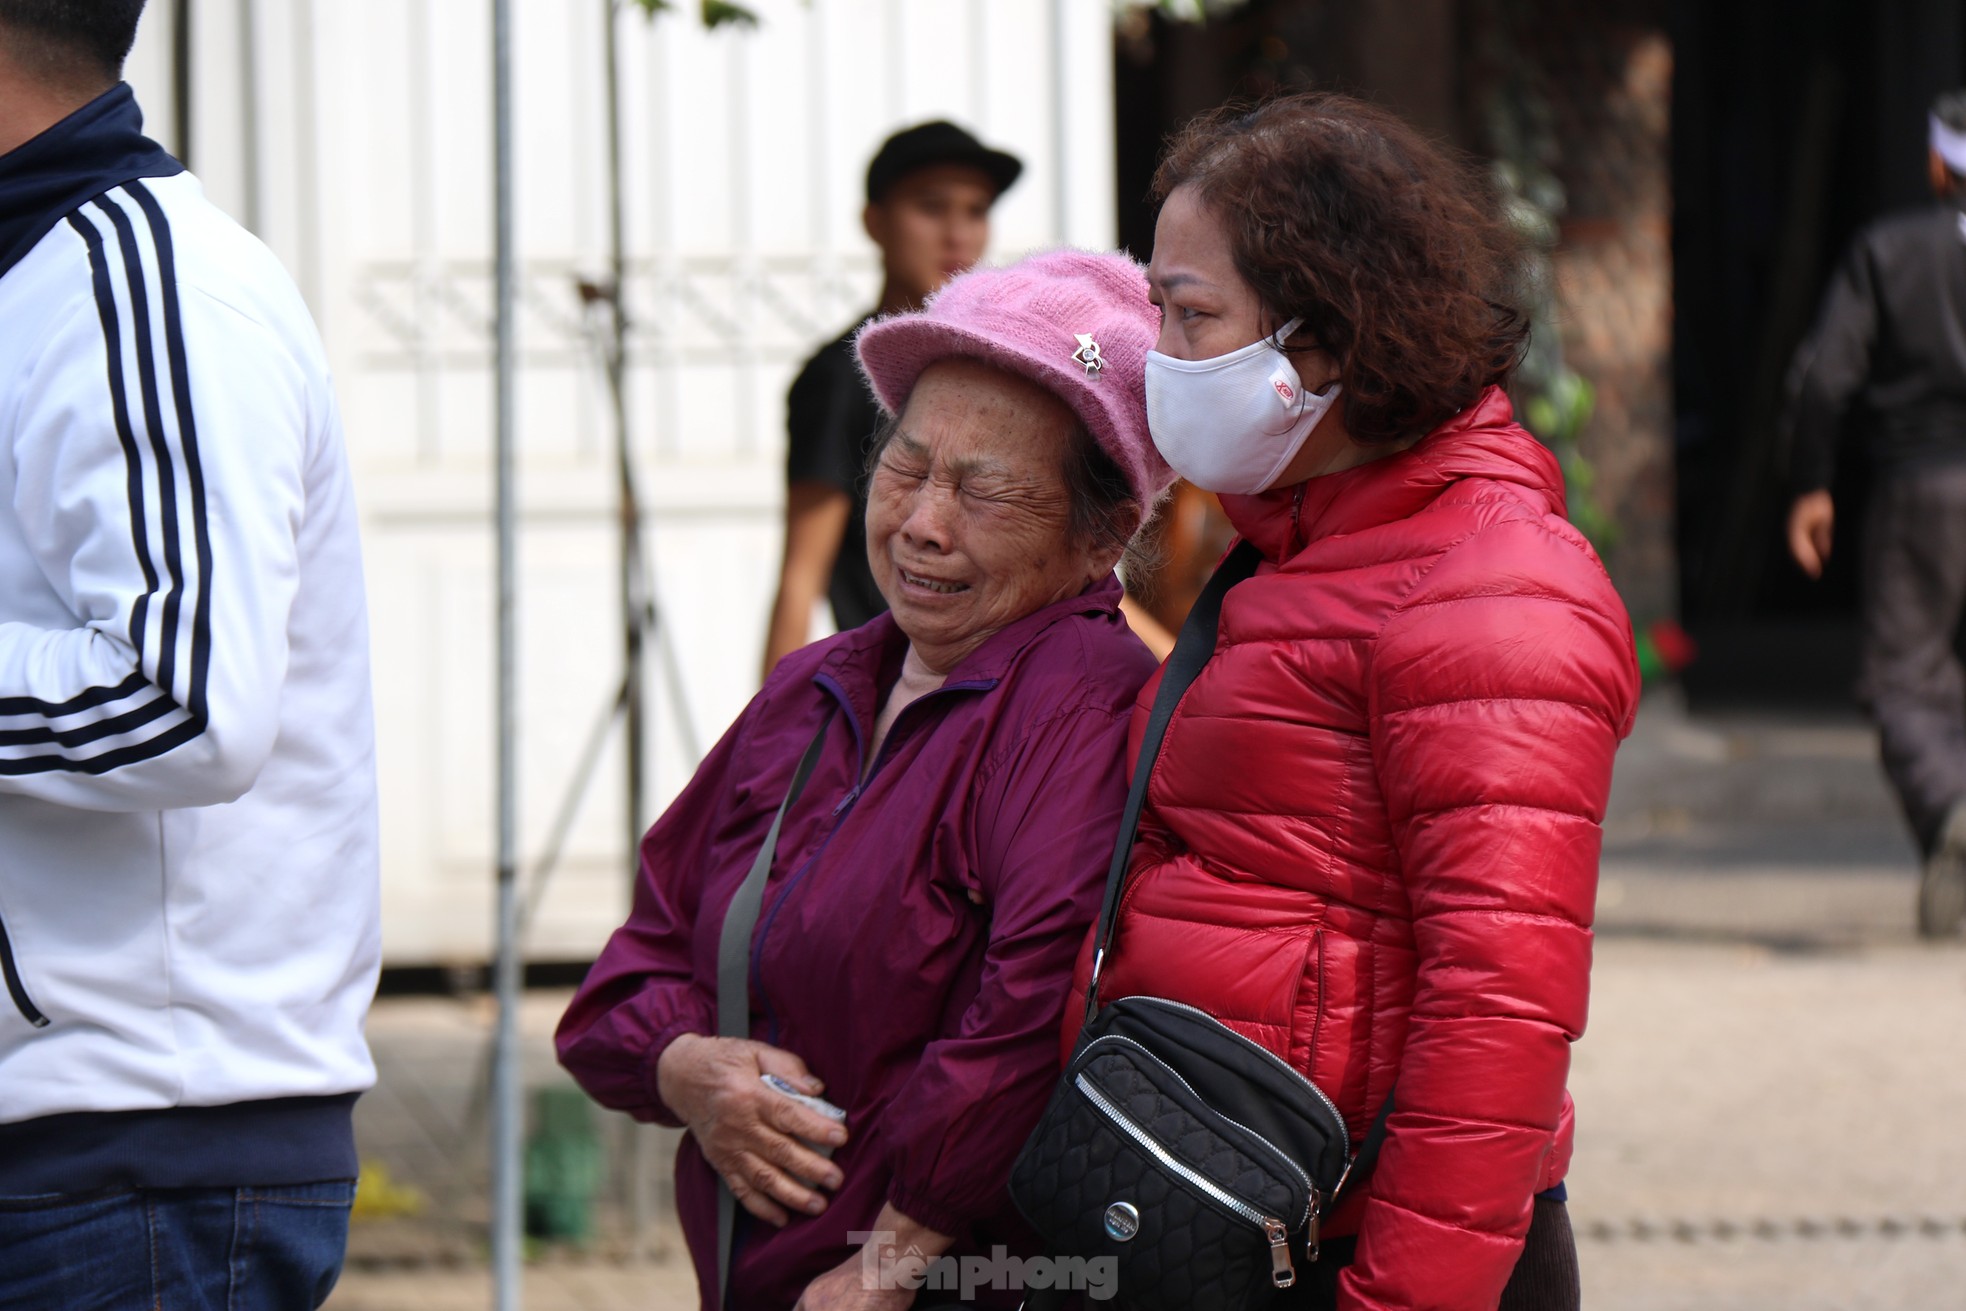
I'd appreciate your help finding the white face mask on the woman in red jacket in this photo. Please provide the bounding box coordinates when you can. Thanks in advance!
[1146,318,1339,493]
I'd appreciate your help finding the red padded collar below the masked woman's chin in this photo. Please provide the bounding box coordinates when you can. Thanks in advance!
[1221,387,1563,562]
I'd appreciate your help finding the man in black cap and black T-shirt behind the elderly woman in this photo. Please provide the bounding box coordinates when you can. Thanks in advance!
[765,122,1024,672]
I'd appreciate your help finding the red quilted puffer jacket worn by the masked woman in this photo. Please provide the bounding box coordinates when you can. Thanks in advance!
[1066,389,1638,1311]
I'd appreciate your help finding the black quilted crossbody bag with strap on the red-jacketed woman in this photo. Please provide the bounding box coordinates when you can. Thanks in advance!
[1011,542,1392,1311]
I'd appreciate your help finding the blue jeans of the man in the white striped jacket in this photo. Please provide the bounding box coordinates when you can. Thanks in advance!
[0,1179,356,1311]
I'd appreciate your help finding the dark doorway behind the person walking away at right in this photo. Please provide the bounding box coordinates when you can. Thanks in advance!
[1671,0,1966,704]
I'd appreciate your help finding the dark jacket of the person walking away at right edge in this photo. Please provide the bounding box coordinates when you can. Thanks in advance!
[1787,199,1966,493]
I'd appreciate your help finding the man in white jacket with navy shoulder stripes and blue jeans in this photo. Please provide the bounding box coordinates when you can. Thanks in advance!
[0,0,379,1311]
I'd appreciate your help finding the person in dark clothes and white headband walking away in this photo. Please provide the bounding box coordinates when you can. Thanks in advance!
[1787,90,1966,938]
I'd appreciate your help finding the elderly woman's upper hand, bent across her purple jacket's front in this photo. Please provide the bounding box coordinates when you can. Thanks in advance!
[655,1034,847,1226]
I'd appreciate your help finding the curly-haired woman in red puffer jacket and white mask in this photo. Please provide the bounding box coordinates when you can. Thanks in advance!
[1066,94,1638,1311]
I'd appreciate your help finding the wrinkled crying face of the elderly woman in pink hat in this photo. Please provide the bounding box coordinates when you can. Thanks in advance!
[867,360,1113,672]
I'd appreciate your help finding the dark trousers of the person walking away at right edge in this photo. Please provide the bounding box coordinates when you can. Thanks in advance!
[1858,464,1966,855]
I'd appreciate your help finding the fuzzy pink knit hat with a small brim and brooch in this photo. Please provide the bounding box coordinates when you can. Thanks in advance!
[853,250,1174,509]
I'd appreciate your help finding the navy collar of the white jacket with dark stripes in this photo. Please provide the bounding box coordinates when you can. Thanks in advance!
[0,83,185,277]
